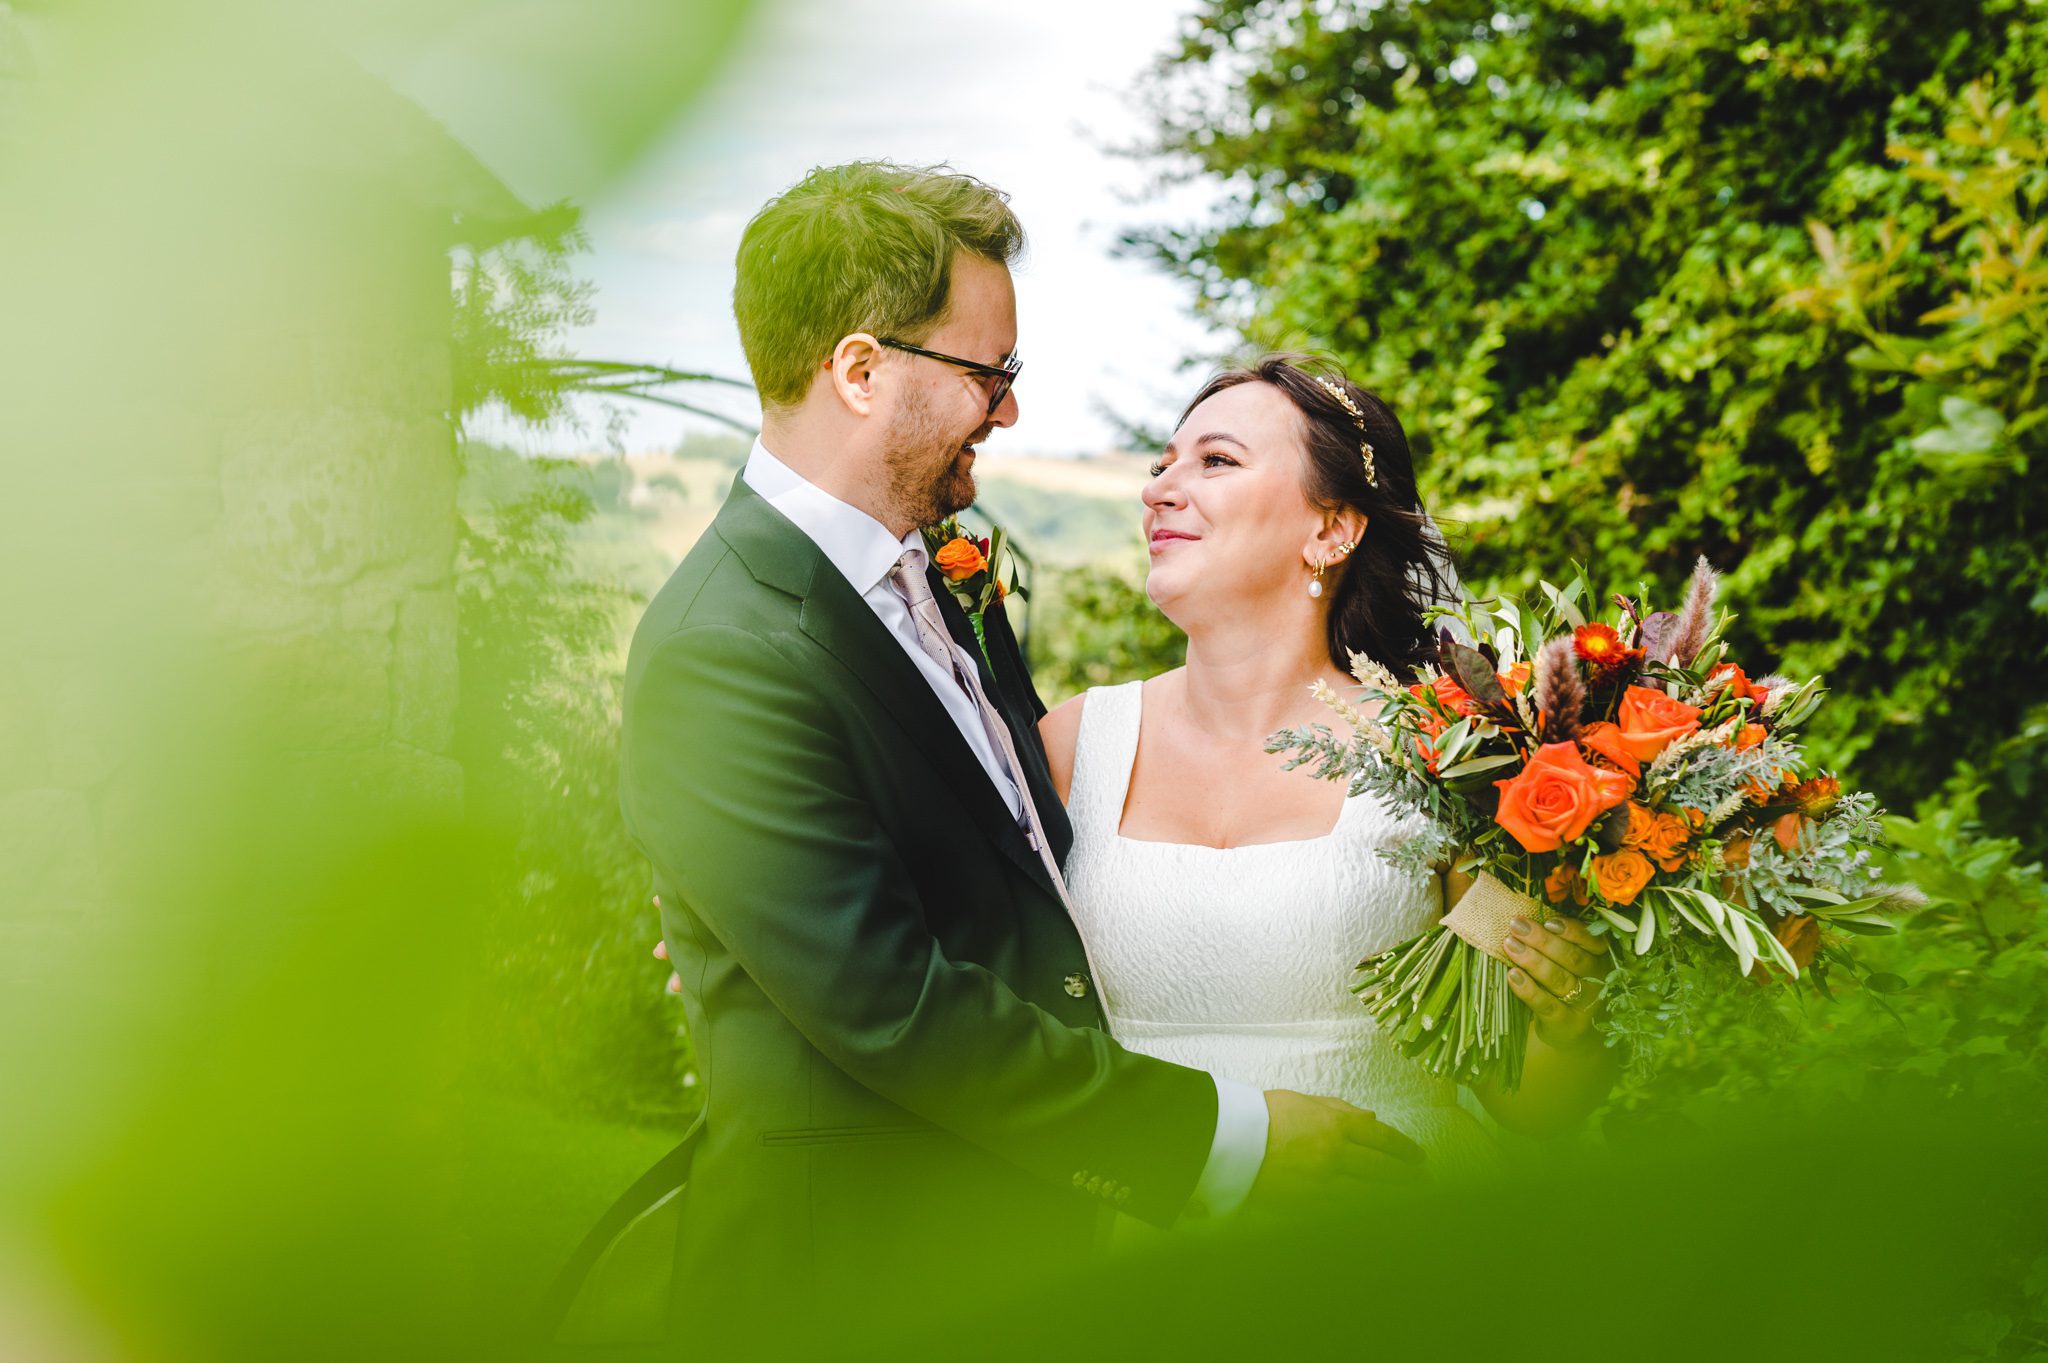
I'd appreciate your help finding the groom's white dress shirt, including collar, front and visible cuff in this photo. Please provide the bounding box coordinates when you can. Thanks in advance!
[739,440,1268,1216]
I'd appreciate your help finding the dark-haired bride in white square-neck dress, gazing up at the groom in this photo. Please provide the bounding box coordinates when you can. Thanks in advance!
[1040,347,1614,1173]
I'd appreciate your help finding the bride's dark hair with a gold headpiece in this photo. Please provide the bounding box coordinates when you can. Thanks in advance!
[1180,354,1456,673]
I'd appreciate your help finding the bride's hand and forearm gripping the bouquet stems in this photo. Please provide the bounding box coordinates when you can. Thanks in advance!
[1444,870,1622,1136]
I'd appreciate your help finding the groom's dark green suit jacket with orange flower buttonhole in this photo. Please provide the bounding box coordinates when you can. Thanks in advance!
[623,472,1217,1338]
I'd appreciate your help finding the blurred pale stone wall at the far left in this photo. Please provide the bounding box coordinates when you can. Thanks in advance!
[0,2,475,965]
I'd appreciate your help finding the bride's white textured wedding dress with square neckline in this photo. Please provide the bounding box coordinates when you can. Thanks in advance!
[1065,682,1497,1175]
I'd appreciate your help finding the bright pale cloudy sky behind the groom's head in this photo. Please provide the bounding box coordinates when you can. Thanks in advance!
[475,0,1229,454]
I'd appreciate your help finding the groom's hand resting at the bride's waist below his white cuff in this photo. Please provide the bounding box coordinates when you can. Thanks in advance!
[1245,1089,1423,1212]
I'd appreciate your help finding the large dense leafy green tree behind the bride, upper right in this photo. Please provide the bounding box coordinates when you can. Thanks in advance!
[1133,0,2048,851]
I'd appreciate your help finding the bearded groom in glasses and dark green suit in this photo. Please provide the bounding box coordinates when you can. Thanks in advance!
[598,164,1415,1345]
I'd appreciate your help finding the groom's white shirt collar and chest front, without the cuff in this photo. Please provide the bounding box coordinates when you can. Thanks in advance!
[739,440,1024,819]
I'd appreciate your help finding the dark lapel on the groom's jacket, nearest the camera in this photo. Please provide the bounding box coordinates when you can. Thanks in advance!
[717,479,1059,898]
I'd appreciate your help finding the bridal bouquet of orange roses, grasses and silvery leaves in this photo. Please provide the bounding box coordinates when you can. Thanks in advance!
[1268,559,1890,1091]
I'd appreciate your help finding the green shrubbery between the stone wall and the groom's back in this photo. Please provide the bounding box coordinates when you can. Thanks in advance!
[459,444,690,1117]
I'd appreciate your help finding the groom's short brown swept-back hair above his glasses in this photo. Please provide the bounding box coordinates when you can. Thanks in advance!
[733,162,1024,407]
